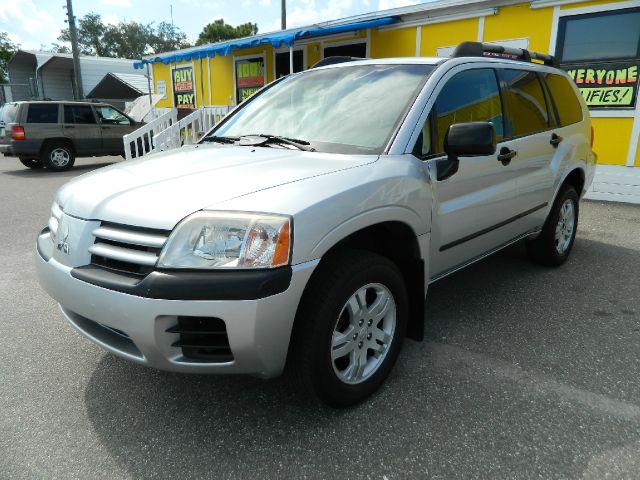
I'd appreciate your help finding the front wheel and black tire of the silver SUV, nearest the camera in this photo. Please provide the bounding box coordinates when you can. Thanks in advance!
[289,250,408,407]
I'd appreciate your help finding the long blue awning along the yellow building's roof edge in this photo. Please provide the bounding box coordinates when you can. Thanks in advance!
[133,17,398,69]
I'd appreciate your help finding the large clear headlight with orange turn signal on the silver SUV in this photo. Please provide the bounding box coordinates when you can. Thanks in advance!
[158,212,291,268]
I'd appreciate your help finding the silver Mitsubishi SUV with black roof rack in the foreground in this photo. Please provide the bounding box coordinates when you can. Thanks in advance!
[36,43,596,406]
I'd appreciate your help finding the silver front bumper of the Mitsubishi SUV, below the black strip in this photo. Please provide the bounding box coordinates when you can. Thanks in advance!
[36,232,318,378]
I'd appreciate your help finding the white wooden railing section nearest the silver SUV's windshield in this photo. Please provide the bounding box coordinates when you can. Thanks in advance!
[153,106,230,151]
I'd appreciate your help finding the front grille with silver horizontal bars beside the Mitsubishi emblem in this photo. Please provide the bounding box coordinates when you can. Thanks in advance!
[89,222,170,275]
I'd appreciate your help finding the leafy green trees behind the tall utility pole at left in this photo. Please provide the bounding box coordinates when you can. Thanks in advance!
[52,12,189,58]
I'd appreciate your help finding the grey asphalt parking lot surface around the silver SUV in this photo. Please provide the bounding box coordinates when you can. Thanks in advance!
[0,156,640,480]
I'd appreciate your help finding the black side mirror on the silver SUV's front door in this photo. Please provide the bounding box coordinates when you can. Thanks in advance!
[438,122,496,180]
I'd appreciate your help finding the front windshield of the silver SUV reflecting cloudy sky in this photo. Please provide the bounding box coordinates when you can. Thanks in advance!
[210,65,434,154]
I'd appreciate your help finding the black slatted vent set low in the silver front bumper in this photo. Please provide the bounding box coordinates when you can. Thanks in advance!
[166,317,233,363]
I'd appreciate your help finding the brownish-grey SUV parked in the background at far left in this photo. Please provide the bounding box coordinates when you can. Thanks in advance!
[0,101,140,171]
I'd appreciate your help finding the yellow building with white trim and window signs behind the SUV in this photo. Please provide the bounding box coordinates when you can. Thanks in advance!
[136,0,640,201]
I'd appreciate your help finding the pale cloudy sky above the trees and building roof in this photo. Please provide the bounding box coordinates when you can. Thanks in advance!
[0,0,424,50]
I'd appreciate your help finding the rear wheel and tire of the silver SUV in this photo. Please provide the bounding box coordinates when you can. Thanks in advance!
[526,185,579,267]
